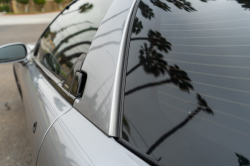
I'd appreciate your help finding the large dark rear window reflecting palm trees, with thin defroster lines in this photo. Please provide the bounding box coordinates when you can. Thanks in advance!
[122,0,250,166]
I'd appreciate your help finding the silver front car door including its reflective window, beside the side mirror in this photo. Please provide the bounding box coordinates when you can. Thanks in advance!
[14,2,96,161]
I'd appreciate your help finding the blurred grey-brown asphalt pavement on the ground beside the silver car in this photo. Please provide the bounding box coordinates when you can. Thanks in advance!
[0,13,55,166]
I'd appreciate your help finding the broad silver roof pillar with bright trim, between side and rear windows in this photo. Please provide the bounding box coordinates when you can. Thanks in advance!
[74,0,136,137]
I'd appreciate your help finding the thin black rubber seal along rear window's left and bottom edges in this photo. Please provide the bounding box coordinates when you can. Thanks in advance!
[115,0,163,166]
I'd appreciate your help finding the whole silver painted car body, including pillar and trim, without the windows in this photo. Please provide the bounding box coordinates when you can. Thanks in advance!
[14,0,148,166]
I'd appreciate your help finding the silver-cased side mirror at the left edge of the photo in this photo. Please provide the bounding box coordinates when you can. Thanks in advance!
[0,43,27,63]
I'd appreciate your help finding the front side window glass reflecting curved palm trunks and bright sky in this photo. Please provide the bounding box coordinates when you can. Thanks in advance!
[37,0,113,80]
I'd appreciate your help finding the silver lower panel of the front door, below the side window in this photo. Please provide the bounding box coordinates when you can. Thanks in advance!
[15,62,72,161]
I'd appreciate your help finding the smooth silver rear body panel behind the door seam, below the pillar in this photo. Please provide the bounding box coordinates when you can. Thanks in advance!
[37,108,148,166]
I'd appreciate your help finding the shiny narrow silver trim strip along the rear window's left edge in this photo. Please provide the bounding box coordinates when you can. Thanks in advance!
[108,0,139,137]
